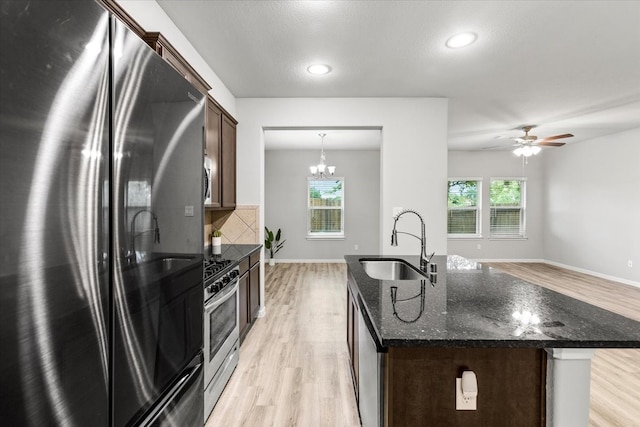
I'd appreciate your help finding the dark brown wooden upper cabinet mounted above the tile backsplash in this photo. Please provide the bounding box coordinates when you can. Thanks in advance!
[205,96,238,209]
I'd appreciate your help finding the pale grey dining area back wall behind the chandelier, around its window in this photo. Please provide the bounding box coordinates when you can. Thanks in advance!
[264,150,380,261]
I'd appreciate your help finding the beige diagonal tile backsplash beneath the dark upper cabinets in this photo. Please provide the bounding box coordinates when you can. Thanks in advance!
[204,205,260,246]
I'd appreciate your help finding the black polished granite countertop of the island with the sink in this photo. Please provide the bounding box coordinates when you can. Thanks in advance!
[345,255,640,350]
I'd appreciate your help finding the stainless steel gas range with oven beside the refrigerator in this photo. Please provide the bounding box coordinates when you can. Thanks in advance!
[204,257,240,422]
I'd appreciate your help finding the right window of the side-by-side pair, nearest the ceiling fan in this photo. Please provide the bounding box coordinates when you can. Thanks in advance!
[489,178,526,237]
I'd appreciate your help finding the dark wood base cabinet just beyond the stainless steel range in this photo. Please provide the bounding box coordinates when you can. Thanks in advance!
[239,250,260,344]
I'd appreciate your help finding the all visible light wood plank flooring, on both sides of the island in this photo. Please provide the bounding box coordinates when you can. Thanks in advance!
[206,263,640,427]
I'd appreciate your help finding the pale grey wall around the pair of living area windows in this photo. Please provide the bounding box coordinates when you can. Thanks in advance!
[449,150,548,261]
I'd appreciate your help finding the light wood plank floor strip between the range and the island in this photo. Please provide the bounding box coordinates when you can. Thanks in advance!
[206,264,360,427]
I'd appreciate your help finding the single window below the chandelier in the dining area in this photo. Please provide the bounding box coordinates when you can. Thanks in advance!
[307,178,344,239]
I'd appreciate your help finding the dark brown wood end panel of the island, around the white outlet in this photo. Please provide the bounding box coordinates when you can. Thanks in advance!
[384,347,546,427]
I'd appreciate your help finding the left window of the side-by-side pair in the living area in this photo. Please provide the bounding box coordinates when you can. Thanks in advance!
[447,178,482,237]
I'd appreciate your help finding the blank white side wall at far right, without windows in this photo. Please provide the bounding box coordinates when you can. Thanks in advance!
[544,128,640,285]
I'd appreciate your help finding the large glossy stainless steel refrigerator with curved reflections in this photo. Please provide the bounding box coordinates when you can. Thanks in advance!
[0,0,204,426]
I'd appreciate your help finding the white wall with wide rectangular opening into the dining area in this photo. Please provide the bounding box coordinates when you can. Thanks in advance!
[237,98,447,254]
